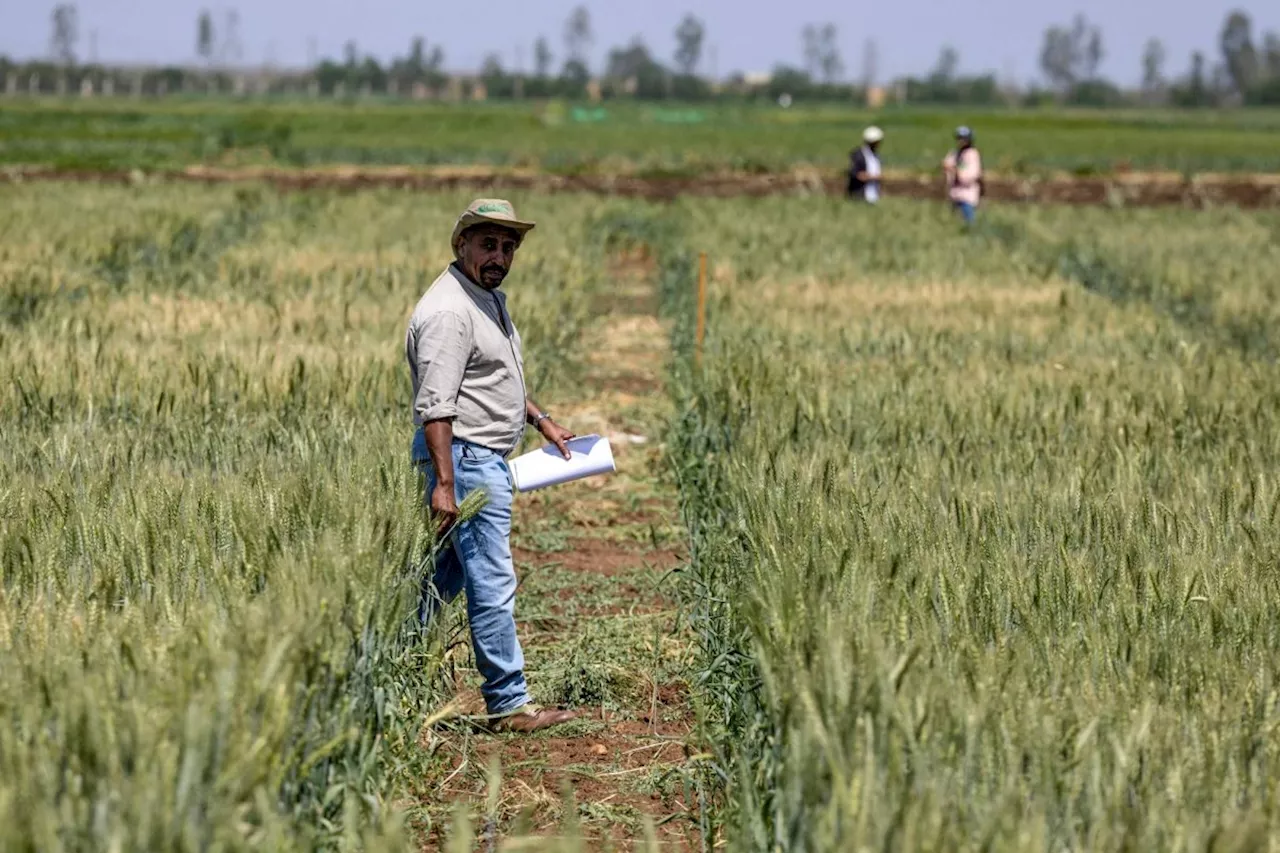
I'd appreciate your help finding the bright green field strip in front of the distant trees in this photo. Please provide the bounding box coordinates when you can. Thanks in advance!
[0,97,1280,181]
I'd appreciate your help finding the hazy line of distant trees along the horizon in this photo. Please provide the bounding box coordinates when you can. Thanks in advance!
[0,3,1280,108]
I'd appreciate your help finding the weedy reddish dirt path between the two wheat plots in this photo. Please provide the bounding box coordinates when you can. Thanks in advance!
[417,249,701,850]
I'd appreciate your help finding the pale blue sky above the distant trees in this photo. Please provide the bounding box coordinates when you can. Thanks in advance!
[0,0,1280,83]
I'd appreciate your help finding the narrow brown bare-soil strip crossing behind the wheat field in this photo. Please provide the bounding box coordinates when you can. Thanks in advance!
[10,167,1280,209]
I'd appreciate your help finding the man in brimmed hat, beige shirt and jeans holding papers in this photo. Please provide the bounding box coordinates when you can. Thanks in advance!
[404,199,577,733]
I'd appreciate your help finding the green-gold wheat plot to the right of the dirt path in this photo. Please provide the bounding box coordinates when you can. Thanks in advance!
[654,200,1280,850]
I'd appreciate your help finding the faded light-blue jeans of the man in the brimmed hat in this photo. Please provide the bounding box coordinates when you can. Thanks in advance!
[413,429,530,713]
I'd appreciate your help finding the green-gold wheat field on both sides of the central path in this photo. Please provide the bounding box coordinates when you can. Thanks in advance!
[0,178,1280,852]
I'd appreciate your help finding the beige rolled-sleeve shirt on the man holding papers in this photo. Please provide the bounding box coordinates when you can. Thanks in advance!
[404,265,527,456]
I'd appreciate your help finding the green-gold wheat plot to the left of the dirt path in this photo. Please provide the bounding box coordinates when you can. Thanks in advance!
[0,186,616,850]
